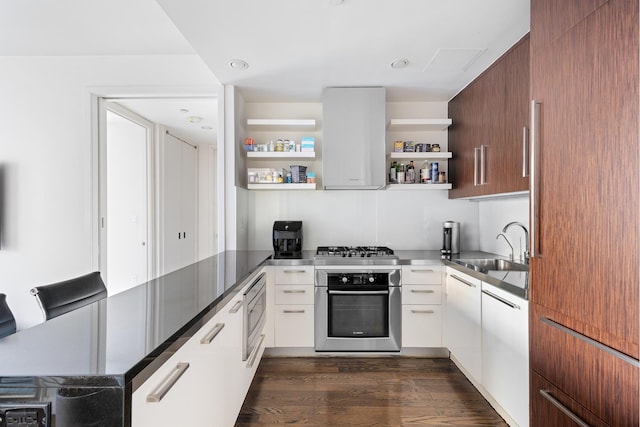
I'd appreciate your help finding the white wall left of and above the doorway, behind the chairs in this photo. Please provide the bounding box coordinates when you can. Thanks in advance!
[0,55,219,329]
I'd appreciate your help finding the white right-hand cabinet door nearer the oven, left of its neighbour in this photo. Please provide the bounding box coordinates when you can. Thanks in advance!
[446,267,482,383]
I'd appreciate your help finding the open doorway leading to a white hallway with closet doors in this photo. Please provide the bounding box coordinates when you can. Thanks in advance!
[96,96,223,294]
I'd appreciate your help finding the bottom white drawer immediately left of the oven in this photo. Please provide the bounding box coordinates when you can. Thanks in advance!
[275,305,314,347]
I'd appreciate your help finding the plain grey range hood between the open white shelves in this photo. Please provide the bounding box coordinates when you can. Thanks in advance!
[322,87,386,190]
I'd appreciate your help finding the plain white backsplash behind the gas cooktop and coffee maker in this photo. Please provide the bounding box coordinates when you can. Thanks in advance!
[248,190,479,250]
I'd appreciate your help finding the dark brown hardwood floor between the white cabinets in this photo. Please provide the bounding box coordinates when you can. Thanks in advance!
[236,357,507,427]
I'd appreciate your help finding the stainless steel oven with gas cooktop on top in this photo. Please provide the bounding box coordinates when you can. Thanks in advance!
[315,247,402,351]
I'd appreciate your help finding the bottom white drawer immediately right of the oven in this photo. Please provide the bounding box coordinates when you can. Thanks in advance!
[402,305,442,347]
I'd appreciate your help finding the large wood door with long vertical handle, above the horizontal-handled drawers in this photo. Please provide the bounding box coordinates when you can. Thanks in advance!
[530,0,640,358]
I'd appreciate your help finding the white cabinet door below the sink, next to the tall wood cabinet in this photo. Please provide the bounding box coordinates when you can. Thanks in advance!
[482,282,529,427]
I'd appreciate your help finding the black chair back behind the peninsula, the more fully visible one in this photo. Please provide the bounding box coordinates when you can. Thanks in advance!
[31,271,107,320]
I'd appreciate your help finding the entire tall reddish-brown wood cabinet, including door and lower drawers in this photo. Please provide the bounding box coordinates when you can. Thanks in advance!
[530,0,640,426]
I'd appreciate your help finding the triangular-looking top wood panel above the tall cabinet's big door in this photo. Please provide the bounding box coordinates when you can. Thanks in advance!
[531,0,608,51]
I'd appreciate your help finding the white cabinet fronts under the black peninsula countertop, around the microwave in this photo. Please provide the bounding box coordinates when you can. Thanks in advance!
[131,274,265,427]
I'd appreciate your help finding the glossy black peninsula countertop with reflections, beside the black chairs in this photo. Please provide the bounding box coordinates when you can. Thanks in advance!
[0,251,273,392]
